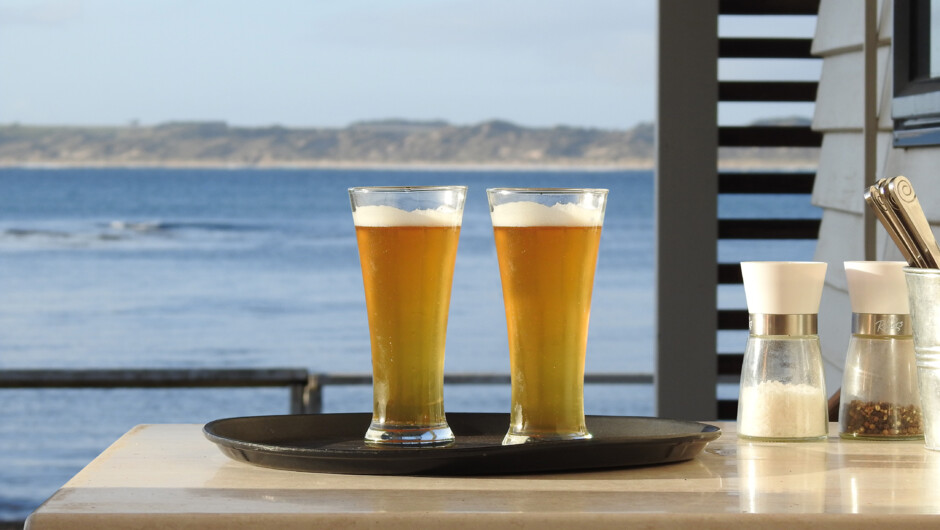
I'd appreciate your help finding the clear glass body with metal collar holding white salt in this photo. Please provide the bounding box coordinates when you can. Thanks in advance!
[738,315,829,442]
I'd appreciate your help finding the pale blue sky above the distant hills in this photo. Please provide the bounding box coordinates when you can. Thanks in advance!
[0,0,812,128]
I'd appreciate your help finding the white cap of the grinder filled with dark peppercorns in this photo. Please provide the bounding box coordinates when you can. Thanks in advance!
[845,261,910,315]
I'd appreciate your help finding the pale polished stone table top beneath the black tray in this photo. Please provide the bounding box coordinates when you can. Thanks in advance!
[27,423,940,530]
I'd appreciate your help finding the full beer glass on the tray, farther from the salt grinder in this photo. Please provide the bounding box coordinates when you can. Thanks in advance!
[349,186,467,446]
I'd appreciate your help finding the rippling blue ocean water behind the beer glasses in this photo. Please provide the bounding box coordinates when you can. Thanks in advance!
[0,169,819,521]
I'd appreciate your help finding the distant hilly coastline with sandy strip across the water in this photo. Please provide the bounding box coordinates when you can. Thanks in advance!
[0,120,818,171]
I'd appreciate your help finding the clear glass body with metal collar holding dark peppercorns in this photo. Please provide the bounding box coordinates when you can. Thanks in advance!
[839,313,924,440]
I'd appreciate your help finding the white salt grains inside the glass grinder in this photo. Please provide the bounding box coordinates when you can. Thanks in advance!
[738,381,829,439]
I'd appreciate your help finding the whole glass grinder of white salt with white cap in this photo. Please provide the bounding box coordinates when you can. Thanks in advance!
[738,261,829,442]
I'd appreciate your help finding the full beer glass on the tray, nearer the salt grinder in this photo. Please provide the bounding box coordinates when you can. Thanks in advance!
[486,188,607,445]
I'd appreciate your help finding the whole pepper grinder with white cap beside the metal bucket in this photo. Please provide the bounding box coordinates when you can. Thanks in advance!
[839,261,924,440]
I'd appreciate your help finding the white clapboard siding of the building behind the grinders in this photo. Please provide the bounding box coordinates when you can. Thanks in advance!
[813,0,940,393]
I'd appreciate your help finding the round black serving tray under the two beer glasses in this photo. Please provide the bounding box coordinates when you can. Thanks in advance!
[203,413,721,475]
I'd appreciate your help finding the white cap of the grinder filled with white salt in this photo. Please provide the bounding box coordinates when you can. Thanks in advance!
[741,261,826,315]
